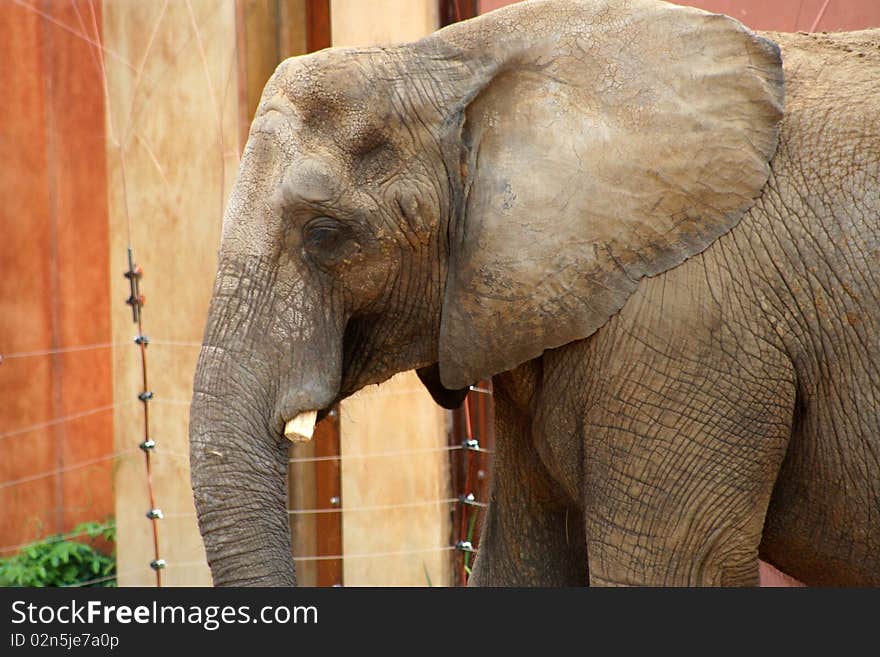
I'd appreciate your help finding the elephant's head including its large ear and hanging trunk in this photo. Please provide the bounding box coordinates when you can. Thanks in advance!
[190,0,782,584]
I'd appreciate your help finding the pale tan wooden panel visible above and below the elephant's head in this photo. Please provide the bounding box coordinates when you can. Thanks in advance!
[331,0,451,586]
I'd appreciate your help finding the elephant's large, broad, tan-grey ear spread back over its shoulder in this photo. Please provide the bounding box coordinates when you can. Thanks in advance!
[429,0,783,389]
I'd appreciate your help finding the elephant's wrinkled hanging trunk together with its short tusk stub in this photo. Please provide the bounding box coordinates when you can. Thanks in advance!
[190,258,341,586]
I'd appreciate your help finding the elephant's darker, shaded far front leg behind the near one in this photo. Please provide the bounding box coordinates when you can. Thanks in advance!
[469,383,588,586]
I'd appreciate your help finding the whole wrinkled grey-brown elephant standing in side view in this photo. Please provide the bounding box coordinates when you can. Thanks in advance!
[190,0,880,586]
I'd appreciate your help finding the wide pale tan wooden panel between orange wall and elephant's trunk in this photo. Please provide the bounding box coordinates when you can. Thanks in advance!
[103,0,239,586]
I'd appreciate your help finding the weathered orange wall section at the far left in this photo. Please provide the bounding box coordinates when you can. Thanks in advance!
[0,0,113,556]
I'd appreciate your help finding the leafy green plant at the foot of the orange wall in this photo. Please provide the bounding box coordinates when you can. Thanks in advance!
[0,520,116,587]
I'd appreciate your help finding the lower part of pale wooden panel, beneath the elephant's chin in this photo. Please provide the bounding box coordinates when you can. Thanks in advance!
[340,372,451,586]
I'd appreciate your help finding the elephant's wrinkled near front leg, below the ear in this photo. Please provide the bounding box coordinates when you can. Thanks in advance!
[584,322,795,586]
